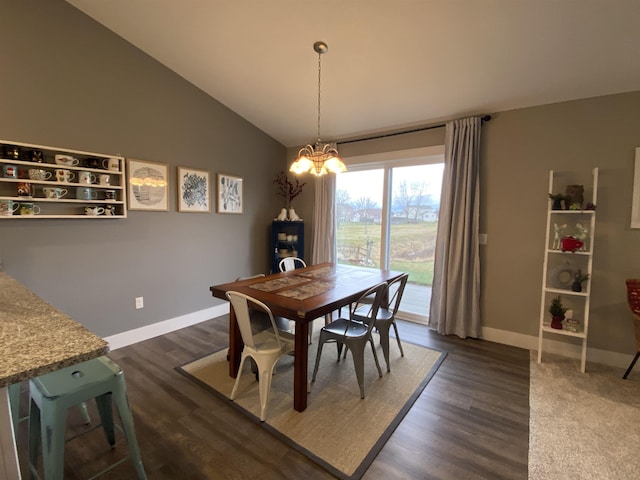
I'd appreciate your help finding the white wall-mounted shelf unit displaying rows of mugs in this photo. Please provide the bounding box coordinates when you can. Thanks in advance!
[0,140,127,221]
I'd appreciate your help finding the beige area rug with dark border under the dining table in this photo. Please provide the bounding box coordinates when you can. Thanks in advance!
[177,339,446,479]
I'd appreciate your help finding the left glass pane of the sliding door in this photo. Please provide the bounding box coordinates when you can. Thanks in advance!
[336,169,384,268]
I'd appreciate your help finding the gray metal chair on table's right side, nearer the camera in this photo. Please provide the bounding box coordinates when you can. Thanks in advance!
[311,282,387,398]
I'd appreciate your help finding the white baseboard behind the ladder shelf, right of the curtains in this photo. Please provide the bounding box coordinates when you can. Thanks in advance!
[481,327,633,368]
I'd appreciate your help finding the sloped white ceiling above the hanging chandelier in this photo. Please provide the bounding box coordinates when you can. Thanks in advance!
[67,0,640,147]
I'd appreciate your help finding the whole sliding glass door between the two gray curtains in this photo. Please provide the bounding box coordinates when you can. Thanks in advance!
[336,155,444,322]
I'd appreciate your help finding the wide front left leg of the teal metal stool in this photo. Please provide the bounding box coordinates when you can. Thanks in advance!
[40,399,67,480]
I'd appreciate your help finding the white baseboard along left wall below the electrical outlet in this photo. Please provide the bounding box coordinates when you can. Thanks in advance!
[105,302,229,350]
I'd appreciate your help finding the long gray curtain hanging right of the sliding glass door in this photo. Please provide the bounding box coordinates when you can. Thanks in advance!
[429,117,482,338]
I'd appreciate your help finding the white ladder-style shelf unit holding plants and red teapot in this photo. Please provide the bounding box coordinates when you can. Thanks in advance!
[538,168,598,373]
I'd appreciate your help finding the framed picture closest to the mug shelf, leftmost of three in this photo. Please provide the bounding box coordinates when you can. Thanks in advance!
[127,158,169,212]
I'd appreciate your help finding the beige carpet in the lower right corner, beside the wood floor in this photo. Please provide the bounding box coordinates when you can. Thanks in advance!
[529,351,640,480]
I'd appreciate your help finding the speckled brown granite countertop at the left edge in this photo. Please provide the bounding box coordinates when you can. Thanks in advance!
[0,272,109,387]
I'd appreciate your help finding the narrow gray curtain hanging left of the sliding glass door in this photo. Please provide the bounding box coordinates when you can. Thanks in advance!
[311,174,336,265]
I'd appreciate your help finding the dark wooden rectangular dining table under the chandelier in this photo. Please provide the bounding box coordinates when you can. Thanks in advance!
[210,263,402,412]
